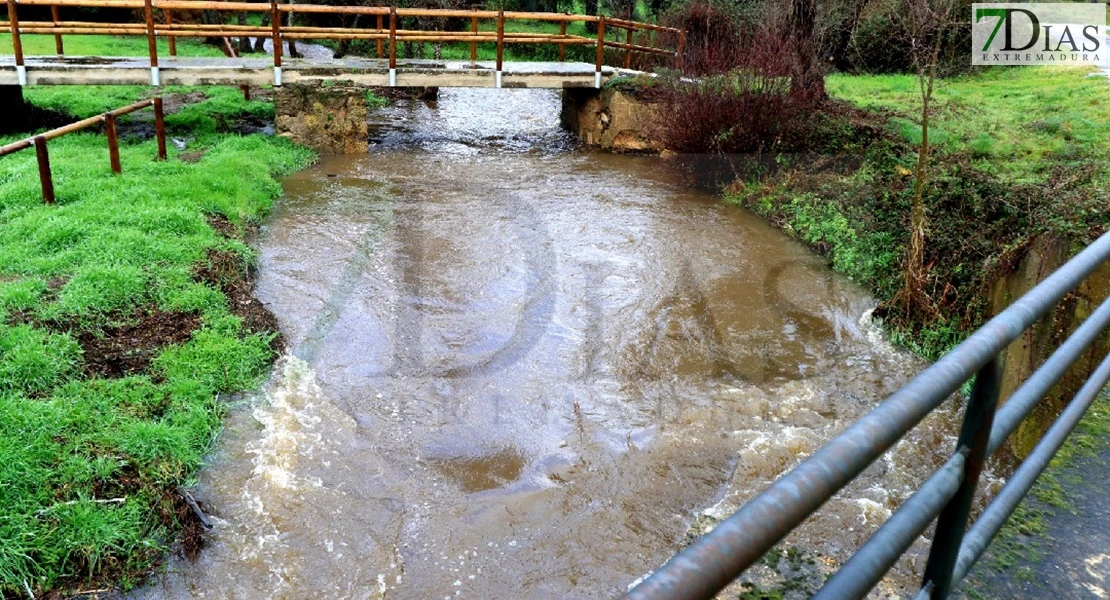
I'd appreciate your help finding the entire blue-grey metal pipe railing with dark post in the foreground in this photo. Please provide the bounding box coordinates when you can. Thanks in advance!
[626,228,1110,600]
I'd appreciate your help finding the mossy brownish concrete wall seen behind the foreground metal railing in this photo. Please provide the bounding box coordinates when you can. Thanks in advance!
[990,235,1110,457]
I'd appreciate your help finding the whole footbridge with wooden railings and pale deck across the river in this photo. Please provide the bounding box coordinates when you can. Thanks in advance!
[0,0,685,89]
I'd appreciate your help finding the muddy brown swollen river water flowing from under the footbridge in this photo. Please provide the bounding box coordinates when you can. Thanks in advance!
[132,90,981,599]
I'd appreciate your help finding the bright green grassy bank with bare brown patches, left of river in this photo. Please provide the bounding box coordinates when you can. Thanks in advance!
[0,88,312,597]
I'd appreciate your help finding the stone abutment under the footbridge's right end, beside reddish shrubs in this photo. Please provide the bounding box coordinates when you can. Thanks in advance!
[561,89,663,154]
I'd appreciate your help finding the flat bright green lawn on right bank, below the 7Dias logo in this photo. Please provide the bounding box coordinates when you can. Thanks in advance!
[828,67,1110,183]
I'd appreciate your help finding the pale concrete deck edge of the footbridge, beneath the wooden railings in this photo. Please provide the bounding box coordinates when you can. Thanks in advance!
[0,55,636,89]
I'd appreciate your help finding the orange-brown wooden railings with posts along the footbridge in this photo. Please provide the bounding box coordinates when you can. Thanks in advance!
[0,0,686,87]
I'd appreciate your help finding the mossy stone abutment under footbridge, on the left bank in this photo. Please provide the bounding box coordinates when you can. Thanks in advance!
[274,82,369,154]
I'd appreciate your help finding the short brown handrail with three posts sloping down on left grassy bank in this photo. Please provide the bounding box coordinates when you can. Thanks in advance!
[0,98,165,204]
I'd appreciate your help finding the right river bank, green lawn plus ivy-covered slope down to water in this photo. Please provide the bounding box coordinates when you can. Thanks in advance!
[728,68,1110,358]
